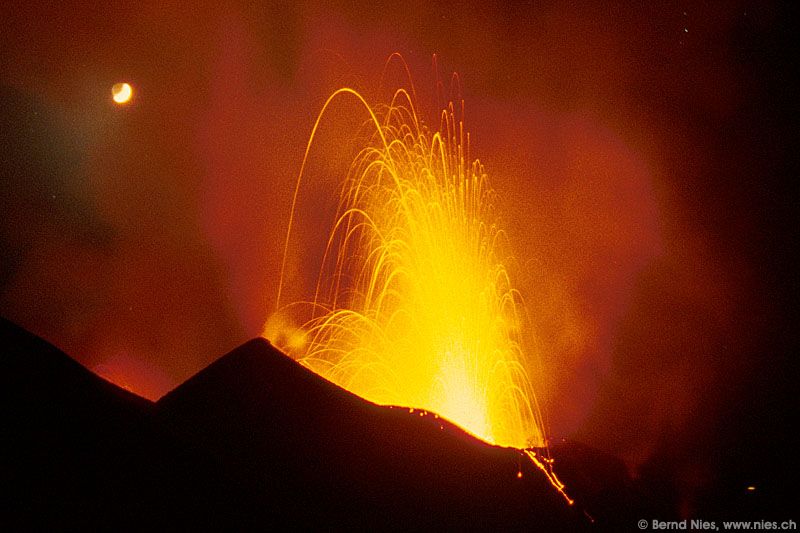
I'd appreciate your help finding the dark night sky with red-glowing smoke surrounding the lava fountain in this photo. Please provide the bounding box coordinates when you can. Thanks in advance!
[0,1,798,519]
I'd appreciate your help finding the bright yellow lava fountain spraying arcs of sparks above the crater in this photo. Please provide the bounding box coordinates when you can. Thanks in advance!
[272,88,544,448]
